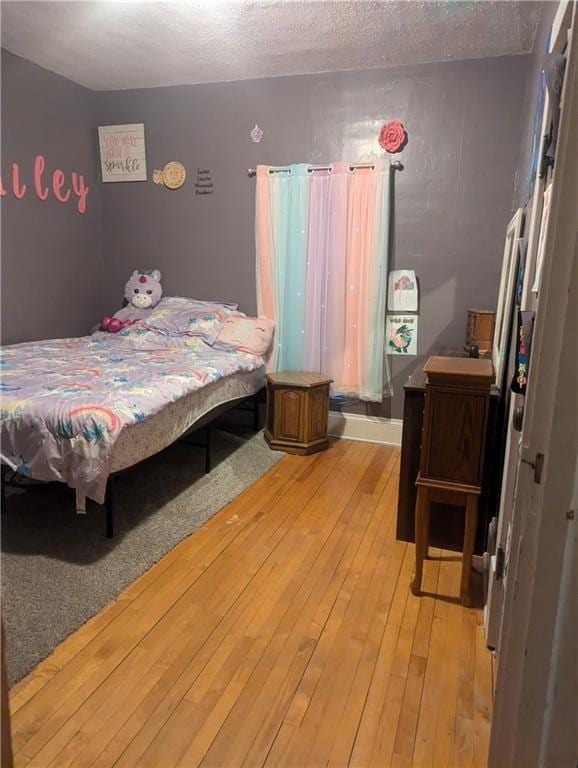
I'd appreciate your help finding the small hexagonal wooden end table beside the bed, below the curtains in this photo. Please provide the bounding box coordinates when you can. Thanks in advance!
[265,371,333,454]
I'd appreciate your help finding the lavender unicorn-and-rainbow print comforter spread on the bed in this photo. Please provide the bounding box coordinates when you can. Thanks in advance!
[0,330,263,504]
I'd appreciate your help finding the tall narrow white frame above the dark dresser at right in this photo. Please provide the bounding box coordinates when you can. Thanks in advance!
[492,208,524,389]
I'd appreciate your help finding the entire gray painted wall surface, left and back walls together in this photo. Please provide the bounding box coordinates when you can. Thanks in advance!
[2,51,536,417]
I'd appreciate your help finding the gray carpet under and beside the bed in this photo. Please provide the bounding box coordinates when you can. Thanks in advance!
[2,424,283,683]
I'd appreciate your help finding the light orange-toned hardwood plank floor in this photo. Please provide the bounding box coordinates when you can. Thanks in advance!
[11,441,492,768]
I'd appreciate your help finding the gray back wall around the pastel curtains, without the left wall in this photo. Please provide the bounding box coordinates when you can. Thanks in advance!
[97,56,532,417]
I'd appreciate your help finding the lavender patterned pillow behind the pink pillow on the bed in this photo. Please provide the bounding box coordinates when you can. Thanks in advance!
[141,304,231,344]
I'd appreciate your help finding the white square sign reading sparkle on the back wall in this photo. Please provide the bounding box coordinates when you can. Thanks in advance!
[98,123,147,182]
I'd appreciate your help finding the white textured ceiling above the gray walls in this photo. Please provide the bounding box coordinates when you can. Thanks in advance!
[1,0,541,90]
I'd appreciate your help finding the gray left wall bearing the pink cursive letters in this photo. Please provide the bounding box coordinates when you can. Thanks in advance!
[1,51,102,343]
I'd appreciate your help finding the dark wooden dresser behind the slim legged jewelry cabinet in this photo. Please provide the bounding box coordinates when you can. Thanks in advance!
[396,350,503,555]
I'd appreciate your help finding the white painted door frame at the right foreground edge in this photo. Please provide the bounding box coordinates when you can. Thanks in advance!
[489,6,578,768]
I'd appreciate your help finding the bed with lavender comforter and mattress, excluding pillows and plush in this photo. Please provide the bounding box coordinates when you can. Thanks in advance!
[0,312,265,536]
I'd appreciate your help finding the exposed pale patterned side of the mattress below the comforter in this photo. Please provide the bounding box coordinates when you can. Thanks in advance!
[110,366,265,472]
